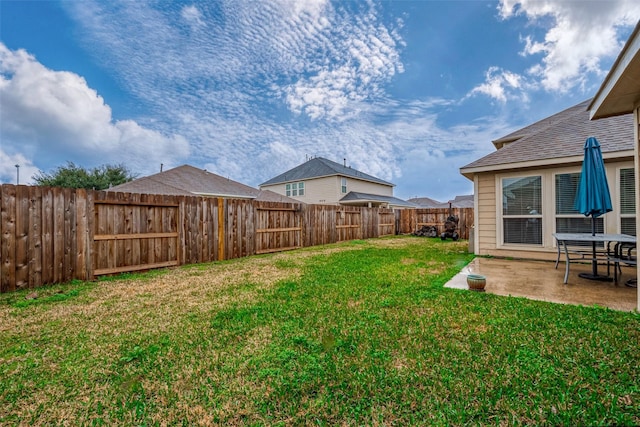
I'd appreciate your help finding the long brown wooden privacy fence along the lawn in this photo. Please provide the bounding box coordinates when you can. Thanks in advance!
[0,184,473,292]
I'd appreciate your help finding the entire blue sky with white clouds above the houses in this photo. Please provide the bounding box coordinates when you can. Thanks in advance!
[0,0,640,201]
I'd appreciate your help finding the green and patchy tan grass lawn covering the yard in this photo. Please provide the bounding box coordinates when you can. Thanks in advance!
[0,237,640,426]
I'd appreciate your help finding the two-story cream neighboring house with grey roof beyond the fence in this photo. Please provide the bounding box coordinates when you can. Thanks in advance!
[260,157,415,208]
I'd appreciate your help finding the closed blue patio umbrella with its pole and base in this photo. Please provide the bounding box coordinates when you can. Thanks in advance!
[574,136,613,279]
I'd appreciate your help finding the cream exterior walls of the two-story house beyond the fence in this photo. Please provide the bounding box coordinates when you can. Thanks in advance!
[261,175,393,205]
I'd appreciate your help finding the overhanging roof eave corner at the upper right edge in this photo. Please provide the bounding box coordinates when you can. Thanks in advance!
[589,21,640,119]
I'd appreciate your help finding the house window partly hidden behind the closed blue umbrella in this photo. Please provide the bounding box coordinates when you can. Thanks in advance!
[555,172,604,233]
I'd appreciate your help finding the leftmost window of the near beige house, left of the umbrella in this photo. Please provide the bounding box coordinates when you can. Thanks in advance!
[502,176,542,245]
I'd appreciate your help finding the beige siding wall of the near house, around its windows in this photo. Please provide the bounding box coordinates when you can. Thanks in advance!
[474,159,638,260]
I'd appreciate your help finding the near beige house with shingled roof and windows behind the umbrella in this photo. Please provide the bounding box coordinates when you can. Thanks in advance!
[460,100,636,259]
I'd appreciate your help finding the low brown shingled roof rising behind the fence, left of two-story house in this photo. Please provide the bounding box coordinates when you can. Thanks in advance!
[108,165,299,203]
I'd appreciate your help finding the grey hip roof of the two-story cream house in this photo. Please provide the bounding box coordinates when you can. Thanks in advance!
[260,157,394,187]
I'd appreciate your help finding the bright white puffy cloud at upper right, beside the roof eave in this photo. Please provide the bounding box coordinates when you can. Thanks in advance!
[467,0,640,103]
